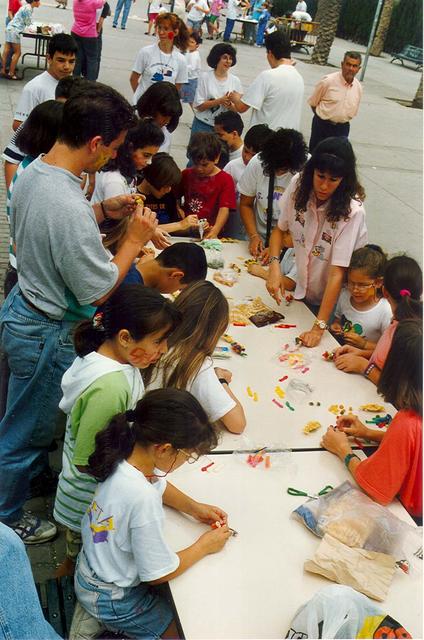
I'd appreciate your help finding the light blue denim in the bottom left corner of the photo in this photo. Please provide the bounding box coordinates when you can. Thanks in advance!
[0,522,60,640]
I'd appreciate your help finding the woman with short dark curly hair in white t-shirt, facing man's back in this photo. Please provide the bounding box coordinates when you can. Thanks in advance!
[191,42,243,136]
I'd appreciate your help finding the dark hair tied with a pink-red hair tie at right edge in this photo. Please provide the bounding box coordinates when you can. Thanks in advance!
[383,255,423,320]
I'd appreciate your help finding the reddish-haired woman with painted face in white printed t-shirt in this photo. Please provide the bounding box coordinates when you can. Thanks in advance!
[130,13,189,104]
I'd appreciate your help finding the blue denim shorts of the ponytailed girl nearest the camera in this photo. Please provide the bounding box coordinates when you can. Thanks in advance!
[75,552,174,640]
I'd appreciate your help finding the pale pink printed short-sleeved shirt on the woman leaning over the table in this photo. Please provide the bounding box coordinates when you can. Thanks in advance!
[278,174,368,304]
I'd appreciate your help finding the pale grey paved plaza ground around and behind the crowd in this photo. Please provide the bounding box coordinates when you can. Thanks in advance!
[0,0,422,579]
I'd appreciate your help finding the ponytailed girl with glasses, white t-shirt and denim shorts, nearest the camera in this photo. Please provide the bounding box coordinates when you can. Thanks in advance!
[75,389,232,639]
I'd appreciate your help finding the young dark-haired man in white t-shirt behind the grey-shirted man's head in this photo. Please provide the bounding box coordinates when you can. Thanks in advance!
[12,33,78,131]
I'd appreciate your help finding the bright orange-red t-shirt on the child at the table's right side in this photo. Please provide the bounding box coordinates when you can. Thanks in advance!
[355,409,423,516]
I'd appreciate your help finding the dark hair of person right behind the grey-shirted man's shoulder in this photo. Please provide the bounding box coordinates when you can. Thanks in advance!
[15,100,63,158]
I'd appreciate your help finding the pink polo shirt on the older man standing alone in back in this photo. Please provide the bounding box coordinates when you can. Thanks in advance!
[308,71,362,122]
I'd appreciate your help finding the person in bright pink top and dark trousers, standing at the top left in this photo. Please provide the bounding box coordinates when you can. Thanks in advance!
[71,0,105,80]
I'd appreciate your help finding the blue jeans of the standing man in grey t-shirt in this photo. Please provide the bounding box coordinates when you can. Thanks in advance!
[0,285,75,524]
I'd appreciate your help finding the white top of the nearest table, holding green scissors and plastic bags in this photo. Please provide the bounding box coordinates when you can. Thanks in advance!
[165,451,422,640]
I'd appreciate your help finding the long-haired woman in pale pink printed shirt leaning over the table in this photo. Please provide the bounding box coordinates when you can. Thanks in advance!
[266,138,368,347]
